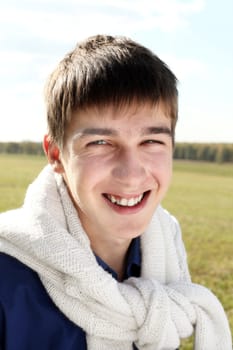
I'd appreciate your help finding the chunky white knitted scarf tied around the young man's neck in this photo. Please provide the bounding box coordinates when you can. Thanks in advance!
[0,166,232,350]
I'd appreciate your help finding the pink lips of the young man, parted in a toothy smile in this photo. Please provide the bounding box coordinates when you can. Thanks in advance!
[103,191,151,215]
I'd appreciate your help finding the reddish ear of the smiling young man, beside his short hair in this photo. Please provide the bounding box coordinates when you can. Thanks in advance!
[43,135,64,174]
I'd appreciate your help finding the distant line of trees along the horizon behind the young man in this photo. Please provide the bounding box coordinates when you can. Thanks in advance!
[0,141,233,163]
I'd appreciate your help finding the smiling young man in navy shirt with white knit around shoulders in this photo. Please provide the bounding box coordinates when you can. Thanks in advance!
[0,35,232,350]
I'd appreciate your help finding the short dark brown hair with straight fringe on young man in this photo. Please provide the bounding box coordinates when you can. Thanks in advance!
[45,35,178,146]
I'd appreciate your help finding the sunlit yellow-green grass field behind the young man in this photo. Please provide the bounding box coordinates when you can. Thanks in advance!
[0,155,233,350]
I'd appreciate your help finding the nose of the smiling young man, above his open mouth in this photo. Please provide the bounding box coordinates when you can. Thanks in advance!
[112,150,146,187]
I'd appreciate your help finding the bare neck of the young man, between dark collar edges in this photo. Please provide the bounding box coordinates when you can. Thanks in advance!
[91,240,131,281]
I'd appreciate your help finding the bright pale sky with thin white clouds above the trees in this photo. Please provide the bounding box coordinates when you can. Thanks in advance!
[0,0,233,143]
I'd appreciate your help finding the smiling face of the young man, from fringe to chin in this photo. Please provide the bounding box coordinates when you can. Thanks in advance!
[53,104,173,240]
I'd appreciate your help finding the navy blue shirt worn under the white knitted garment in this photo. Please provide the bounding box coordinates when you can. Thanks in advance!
[0,238,141,350]
